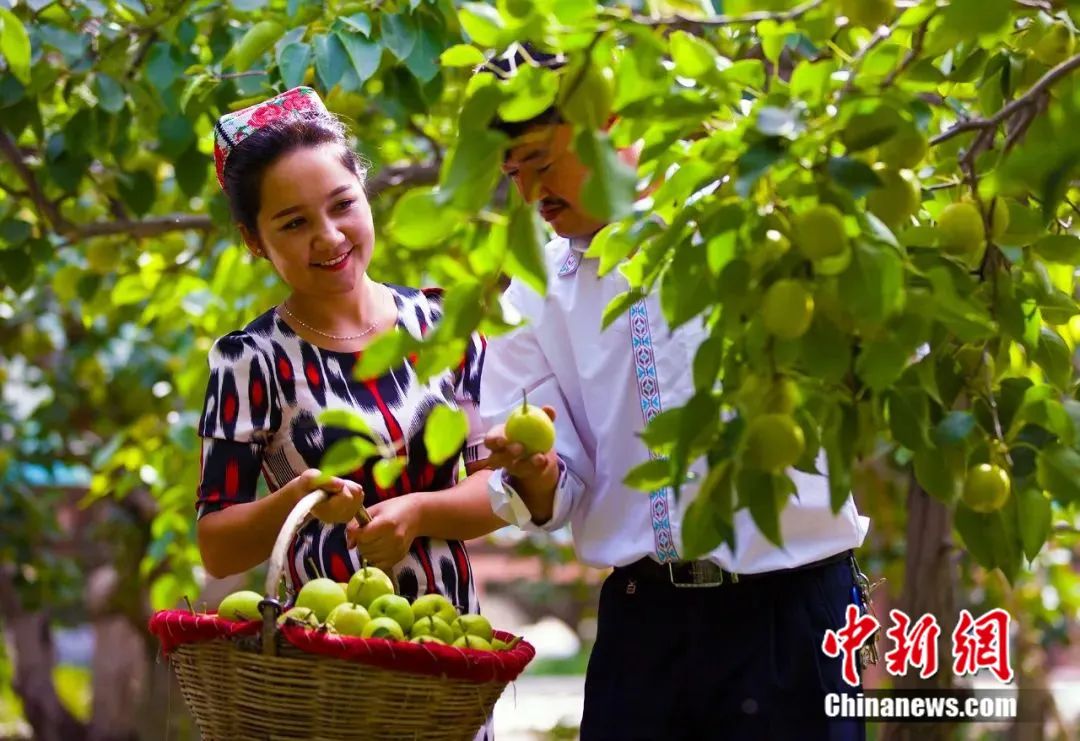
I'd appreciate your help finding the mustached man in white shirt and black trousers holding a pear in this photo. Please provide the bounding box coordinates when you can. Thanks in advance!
[481,46,867,741]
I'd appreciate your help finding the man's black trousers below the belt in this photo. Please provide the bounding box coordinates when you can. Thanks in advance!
[581,561,866,741]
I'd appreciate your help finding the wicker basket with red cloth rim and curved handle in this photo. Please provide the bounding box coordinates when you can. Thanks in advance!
[150,491,535,741]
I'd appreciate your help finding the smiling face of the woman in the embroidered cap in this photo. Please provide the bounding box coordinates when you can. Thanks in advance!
[244,144,375,294]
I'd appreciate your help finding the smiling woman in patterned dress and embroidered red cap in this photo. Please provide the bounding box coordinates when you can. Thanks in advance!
[198,87,503,626]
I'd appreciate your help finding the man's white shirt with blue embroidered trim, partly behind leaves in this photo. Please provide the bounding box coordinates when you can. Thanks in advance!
[480,238,869,574]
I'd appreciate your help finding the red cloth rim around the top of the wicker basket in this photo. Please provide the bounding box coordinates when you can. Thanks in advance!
[149,610,536,683]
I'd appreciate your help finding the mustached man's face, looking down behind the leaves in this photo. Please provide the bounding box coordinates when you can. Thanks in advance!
[502,123,605,237]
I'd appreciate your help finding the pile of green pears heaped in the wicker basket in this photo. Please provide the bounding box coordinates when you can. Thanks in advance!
[217,565,518,651]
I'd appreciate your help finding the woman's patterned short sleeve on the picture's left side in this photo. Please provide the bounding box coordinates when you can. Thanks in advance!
[195,332,272,517]
